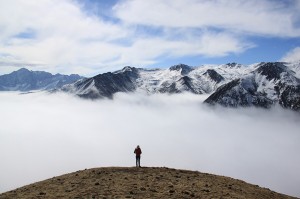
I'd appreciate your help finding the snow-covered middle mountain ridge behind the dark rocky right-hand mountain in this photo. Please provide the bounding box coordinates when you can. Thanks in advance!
[62,64,244,98]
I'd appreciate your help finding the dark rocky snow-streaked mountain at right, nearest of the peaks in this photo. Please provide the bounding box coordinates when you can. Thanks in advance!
[205,62,300,111]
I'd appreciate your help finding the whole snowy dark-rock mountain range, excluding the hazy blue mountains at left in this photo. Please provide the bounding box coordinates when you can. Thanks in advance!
[61,62,300,111]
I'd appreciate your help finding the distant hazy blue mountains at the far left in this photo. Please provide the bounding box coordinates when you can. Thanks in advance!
[0,68,81,91]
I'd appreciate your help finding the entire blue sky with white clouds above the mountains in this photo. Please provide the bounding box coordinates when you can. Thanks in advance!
[0,0,300,76]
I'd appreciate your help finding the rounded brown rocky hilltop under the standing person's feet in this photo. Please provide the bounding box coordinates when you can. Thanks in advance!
[0,167,293,199]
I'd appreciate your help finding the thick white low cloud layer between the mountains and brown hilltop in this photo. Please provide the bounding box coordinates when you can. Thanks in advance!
[0,92,300,197]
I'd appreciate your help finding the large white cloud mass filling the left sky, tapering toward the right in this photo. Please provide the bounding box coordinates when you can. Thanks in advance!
[0,0,252,75]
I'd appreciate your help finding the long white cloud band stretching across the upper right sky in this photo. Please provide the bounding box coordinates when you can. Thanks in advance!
[114,0,300,37]
